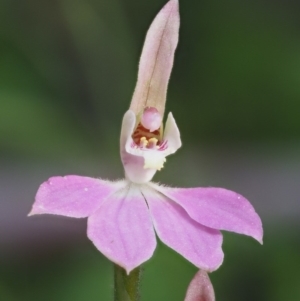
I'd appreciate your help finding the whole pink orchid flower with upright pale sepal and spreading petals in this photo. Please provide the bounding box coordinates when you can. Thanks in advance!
[30,0,262,273]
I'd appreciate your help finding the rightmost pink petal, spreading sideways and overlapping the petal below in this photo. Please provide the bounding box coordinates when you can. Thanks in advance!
[153,184,263,243]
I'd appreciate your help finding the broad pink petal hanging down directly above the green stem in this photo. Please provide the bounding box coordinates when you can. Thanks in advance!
[88,184,156,273]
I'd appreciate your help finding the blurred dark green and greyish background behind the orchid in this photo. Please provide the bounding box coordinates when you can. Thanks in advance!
[0,0,300,301]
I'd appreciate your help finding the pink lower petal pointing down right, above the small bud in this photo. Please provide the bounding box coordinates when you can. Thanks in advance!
[142,186,223,271]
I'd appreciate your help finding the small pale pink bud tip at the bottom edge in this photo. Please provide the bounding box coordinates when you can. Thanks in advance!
[184,270,215,301]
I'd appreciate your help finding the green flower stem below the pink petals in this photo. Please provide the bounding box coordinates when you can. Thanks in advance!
[114,264,141,301]
